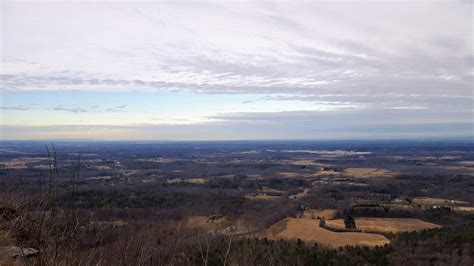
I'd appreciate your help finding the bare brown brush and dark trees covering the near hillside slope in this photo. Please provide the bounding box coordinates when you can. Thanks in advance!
[0,187,474,265]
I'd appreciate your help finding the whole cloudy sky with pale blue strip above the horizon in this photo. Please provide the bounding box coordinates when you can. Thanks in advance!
[0,0,474,140]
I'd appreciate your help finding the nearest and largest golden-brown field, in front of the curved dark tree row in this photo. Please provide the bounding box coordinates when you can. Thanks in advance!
[266,218,390,247]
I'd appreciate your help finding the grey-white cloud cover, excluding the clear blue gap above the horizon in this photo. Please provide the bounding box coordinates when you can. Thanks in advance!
[0,1,474,139]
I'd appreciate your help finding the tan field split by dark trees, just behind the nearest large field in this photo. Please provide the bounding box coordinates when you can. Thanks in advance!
[326,217,441,233]
